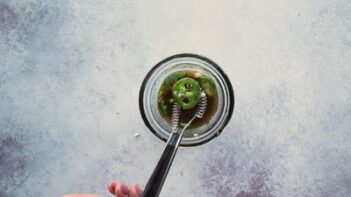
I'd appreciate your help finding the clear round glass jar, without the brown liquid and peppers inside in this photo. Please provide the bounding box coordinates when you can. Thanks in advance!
[139,54,234,146]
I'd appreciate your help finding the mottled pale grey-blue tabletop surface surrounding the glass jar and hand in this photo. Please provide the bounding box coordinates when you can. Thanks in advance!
[0,0,351,197]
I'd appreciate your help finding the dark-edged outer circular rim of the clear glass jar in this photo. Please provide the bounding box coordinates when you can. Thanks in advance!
[139,53,235,146]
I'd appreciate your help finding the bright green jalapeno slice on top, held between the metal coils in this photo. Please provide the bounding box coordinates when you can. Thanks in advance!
[172,77,200,109]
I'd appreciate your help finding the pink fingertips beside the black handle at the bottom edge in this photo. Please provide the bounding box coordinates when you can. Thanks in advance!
[108,181,143,197]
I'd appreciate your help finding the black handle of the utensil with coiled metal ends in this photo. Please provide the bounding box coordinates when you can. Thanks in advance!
[143,132,182,197]
